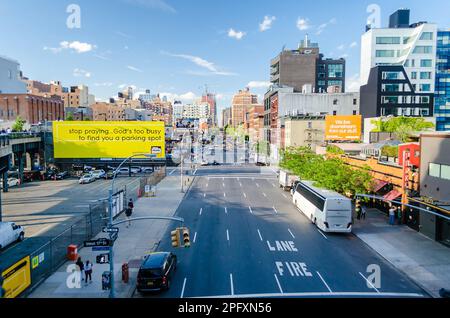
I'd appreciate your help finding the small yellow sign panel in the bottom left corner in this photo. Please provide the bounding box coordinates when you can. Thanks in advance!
[1,256,31,298]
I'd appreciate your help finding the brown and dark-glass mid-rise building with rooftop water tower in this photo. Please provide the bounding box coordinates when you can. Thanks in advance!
[270,36,345,93]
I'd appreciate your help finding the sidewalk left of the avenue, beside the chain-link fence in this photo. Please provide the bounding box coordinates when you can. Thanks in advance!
[28,176,192,298]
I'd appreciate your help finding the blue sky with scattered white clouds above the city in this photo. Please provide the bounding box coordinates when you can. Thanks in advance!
[0,0,450,112]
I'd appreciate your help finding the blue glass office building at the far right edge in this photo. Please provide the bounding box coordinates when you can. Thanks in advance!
[434,29,450,131]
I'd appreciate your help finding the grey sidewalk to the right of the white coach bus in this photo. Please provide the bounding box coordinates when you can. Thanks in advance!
[353,209,450,297]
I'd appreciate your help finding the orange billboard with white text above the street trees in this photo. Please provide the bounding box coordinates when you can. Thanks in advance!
[325,115,362,141]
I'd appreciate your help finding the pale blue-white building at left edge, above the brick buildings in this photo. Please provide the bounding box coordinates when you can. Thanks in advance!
[0,56,27,94]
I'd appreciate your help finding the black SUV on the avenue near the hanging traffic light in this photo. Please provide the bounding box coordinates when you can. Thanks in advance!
[136,252,177,293]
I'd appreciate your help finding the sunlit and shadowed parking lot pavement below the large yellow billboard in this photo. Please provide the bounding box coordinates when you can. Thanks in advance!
[2,177,139,238]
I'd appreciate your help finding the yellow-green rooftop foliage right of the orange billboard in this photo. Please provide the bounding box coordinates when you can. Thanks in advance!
[372,116,435,142]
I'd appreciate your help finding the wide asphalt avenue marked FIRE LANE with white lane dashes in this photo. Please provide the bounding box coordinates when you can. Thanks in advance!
[135,166,427,298]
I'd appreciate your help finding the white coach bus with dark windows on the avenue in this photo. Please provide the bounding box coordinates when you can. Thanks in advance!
[292,181,352,233]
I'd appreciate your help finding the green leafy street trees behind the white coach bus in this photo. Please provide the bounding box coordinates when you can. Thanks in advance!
[280,147,373,196]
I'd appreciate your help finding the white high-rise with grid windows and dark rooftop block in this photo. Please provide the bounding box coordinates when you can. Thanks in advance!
[360,9,437,93]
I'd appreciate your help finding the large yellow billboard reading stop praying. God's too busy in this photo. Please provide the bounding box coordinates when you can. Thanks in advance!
[53,121,166,159]
